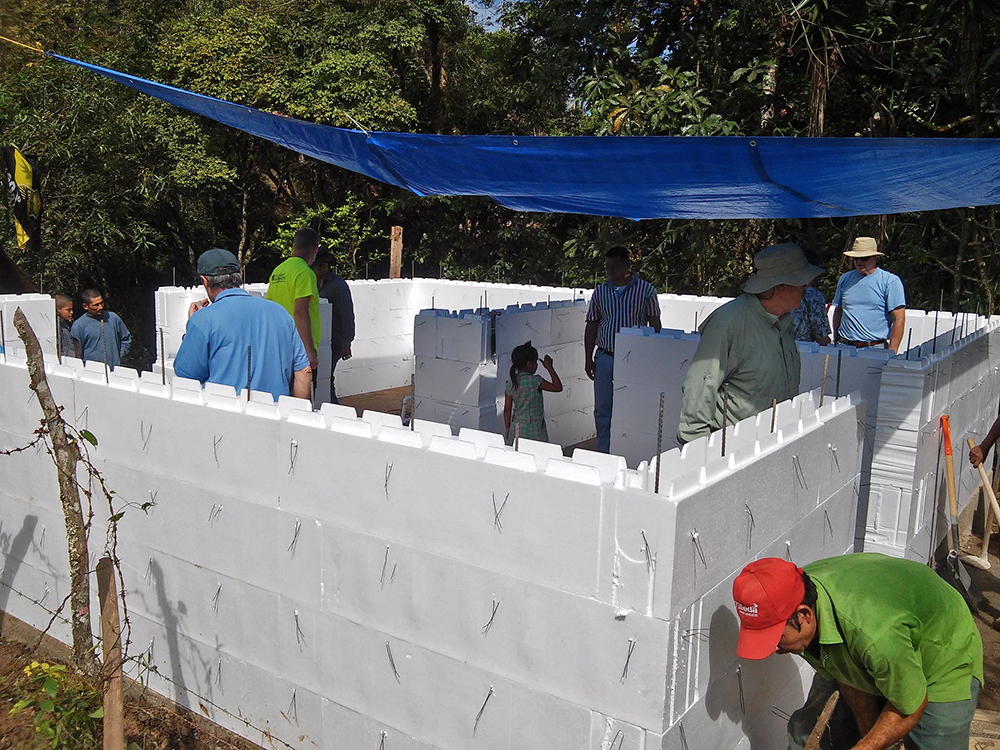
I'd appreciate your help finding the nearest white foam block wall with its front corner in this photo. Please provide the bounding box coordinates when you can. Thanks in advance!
[0,330,859,750]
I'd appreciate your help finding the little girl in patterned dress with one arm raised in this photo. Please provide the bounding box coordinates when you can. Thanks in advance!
[503,341,562,445]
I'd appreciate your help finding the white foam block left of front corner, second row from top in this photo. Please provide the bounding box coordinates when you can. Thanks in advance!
[323,525,667,726]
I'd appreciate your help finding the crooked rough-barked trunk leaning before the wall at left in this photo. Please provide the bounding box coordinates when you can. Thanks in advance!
[14,308,97,676]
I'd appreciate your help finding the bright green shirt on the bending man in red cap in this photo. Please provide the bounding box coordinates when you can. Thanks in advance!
[802,553,983,715]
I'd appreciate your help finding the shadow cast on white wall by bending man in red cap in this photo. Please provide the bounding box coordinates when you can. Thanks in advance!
[705,606,805,750]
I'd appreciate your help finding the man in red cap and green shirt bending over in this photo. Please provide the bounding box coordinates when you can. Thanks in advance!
[733,553,983,750]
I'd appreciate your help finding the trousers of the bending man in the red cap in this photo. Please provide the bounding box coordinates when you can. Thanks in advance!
[788,674,980,750]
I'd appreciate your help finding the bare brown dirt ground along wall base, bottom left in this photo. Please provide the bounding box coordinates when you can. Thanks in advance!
[0,616,261,750]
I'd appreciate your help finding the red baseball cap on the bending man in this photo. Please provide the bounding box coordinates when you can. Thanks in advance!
[733,557,806,659]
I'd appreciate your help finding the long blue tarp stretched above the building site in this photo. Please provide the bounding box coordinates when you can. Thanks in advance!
[50,53,1000,220]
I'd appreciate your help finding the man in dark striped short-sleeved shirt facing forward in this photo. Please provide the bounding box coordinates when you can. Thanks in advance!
[583,246,660,453]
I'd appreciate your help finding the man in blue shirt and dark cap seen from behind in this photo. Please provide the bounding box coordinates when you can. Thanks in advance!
[174,248,312,401]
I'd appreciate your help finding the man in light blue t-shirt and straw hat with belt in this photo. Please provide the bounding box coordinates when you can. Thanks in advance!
[833,237,906,352]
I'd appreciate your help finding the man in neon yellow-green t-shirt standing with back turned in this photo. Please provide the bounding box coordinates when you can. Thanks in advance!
[266,227,320,380]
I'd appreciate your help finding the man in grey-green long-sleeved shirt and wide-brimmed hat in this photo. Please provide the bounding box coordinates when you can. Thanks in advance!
[677,243,823,444]
